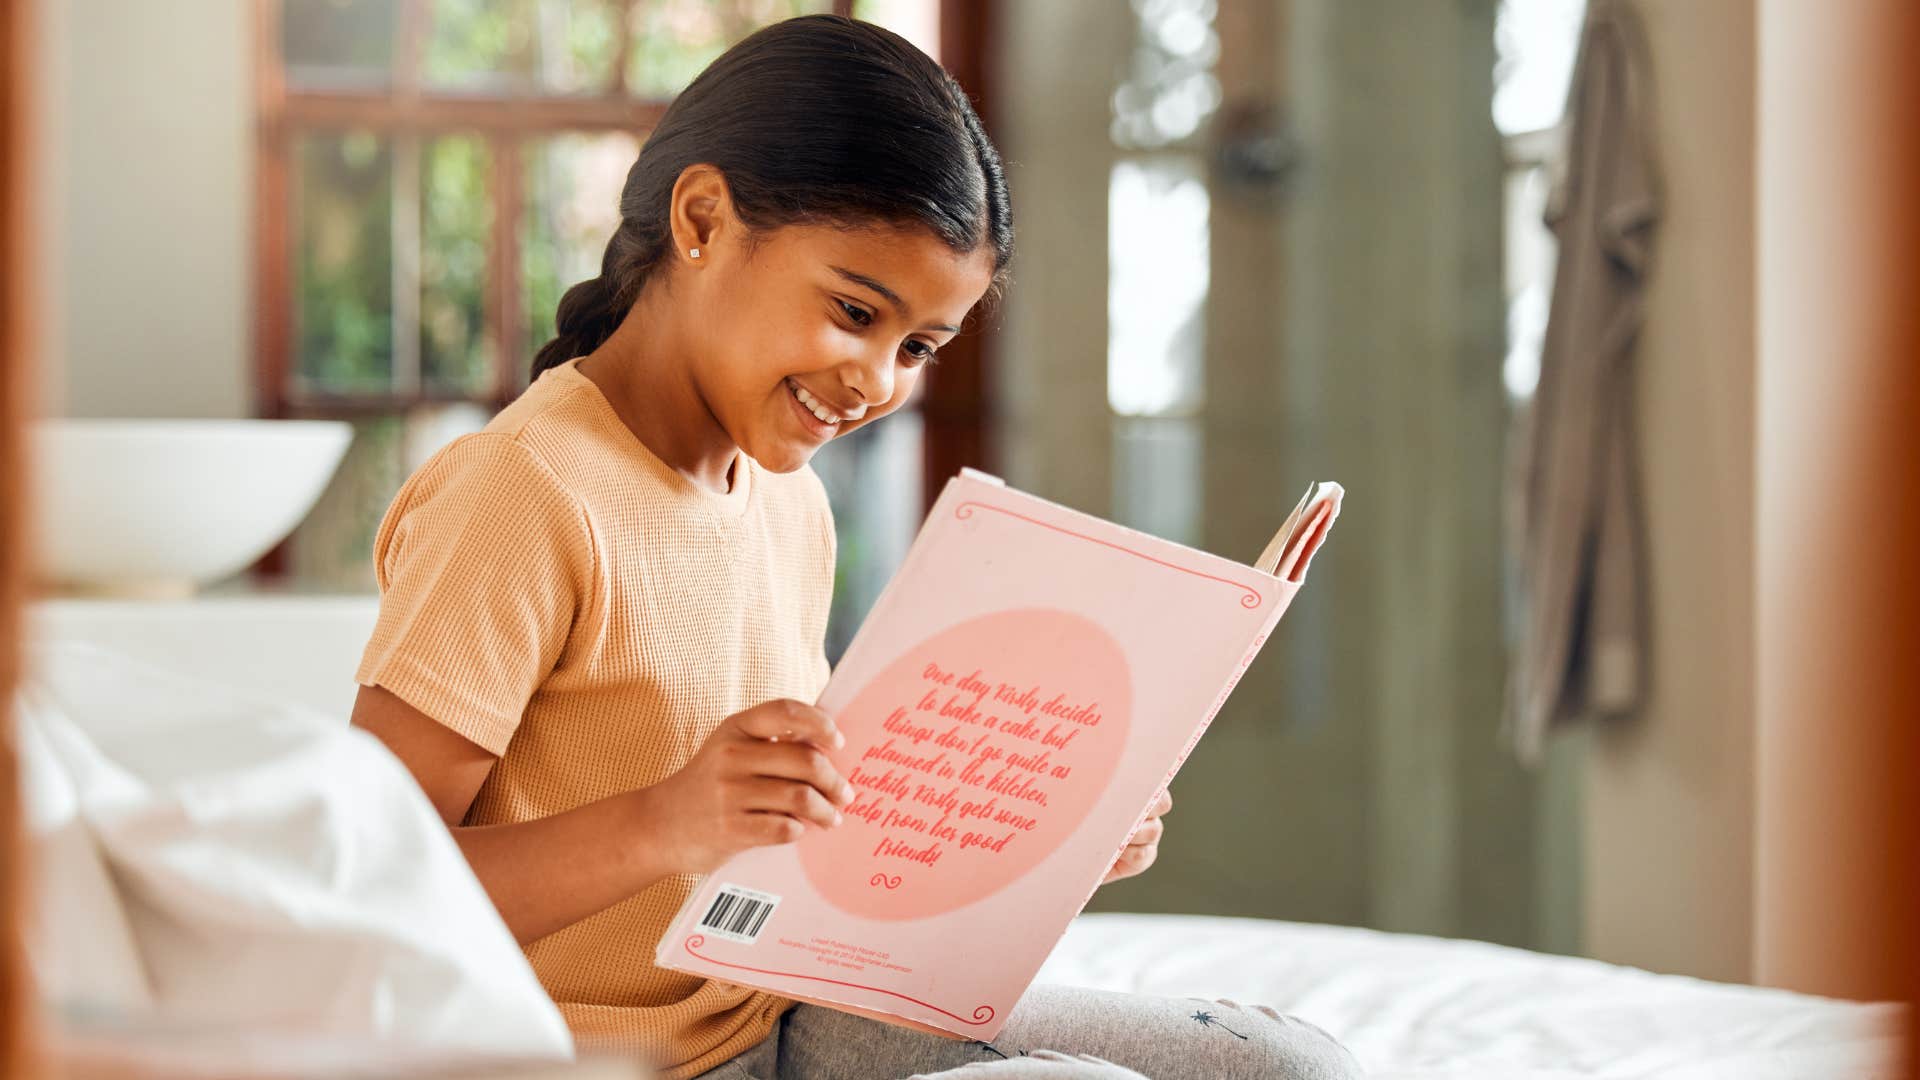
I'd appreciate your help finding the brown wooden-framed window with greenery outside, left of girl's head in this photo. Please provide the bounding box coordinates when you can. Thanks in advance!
[259,0,849,415]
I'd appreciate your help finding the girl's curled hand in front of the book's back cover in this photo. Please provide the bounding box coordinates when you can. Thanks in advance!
[645,698,854,874]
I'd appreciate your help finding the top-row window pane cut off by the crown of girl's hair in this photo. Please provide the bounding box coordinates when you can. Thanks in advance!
[626,0,833,98]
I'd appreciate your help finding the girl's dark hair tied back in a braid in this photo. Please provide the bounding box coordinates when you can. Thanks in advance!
[532,15,1014,379]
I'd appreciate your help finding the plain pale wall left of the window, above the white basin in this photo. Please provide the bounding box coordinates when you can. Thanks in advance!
[40,0,253,417]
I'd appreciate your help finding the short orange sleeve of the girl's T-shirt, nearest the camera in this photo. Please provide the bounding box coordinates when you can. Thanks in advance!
[355,432,595,757]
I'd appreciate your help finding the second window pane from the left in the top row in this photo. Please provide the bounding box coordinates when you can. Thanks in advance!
[424,0,628,94]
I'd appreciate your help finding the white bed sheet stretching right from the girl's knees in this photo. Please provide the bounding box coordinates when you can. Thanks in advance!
[1039,913,1903,1080]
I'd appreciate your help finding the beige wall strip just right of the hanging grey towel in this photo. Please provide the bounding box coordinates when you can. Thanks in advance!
[1584,0,1755,980]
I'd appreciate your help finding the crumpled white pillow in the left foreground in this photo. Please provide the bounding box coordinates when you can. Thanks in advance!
[19,642,572,1059]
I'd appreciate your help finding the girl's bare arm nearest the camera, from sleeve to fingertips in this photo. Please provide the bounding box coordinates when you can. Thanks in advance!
[353,686,852,945]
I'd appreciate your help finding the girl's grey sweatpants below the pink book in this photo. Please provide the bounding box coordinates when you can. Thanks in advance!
[697,984,1363,1080]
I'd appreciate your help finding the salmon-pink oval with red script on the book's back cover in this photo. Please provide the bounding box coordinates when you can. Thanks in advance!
[797,607,1133,919]
